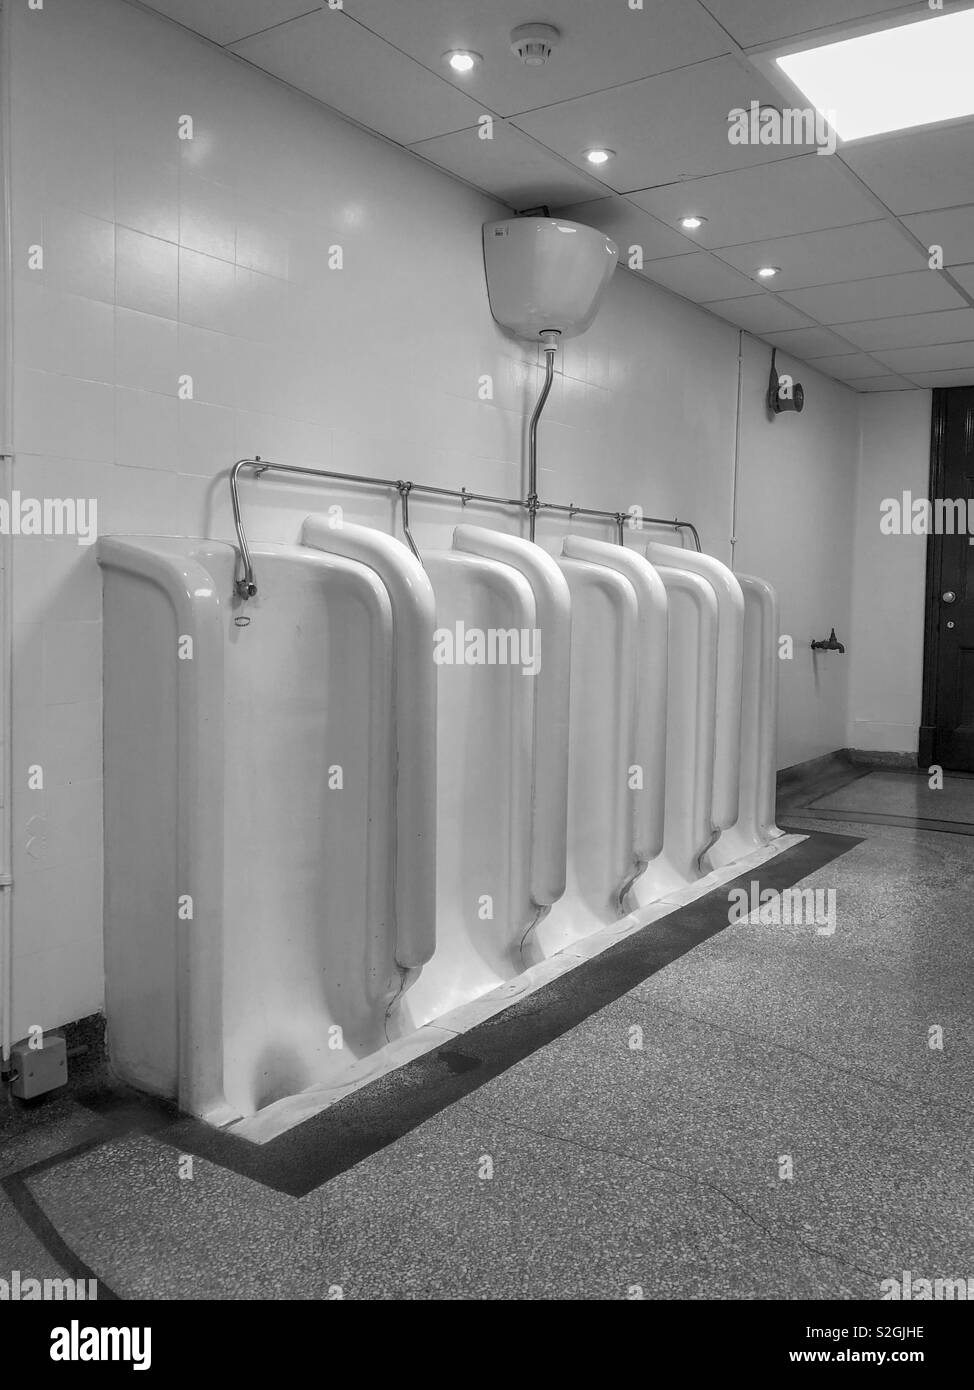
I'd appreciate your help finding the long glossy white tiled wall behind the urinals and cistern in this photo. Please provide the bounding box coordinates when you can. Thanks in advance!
[11,0,856,1036]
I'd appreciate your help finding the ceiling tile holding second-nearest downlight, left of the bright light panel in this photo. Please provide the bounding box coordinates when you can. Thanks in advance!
[505,58,802,193]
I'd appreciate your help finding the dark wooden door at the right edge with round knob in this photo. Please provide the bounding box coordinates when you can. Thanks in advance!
[920,386,974,771]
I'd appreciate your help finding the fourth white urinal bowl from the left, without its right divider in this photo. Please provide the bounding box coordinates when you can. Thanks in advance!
[628,564,717,909]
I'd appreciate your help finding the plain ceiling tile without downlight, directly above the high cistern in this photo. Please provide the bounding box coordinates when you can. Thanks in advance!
[410,121,606,209]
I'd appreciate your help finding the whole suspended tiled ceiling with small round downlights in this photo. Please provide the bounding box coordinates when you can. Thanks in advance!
[134,0,974,391]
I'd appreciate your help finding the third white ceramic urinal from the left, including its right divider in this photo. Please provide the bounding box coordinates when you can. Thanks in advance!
[555,537,667,951]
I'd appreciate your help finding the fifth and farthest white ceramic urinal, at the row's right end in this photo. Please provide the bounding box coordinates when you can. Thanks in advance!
[711,574,781,866]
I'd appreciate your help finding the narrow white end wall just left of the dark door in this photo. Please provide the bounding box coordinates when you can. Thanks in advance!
[848,391,931,753]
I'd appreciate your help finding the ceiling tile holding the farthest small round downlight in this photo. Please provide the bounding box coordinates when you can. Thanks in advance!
[718,221,927,289]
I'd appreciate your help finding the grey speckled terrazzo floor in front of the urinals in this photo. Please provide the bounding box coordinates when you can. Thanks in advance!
[0,774,974,1300]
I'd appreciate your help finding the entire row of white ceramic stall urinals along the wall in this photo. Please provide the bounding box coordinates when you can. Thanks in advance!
[99,516,778,1123]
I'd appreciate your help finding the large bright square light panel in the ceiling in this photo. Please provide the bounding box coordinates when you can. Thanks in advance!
[777,10,974,140]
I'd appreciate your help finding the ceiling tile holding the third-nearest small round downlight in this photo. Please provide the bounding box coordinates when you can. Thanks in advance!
[629,154,877,247]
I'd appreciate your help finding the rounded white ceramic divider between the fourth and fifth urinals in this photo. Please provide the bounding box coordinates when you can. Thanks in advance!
[646,541,745,869]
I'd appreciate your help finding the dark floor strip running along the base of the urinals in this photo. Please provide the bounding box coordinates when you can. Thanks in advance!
[129,830,861,1197]
